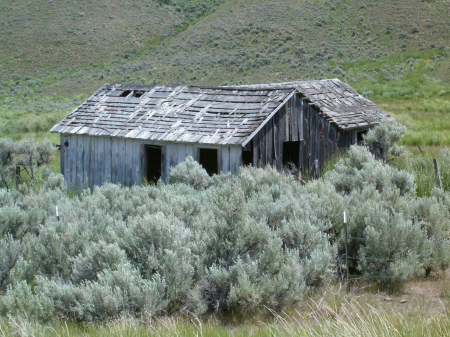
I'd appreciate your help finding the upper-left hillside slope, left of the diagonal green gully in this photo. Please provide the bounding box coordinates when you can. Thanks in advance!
[0,0,224,77]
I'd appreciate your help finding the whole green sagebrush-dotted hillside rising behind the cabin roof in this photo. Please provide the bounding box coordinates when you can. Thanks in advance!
[0,0,450,145]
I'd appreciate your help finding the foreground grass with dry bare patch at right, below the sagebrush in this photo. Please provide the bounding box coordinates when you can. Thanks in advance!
[0,281,450,337]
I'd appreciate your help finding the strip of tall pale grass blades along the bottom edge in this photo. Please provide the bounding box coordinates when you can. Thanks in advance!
[0,298,450,337]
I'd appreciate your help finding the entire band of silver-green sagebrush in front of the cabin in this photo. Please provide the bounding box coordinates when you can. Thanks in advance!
[0,125,450,320]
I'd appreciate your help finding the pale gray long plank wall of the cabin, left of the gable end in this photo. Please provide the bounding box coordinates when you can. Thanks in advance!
[61,134,242,189]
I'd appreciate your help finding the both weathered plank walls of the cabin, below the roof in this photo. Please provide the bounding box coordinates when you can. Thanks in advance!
[61,95,356,189]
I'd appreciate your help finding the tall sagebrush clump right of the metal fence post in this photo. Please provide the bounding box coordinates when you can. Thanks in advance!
[322,146,450,287]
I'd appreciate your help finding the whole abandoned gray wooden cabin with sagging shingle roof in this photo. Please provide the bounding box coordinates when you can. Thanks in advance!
[51,79,389,188]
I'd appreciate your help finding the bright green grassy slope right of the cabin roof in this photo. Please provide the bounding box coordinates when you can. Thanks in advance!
[343,50,450,146]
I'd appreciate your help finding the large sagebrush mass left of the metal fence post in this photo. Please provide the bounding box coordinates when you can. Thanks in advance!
[0,160,336,320]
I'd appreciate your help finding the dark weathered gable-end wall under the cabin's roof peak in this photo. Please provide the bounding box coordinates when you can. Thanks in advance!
[248,95,356,172]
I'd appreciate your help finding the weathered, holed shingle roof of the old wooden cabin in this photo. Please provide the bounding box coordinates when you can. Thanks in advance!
[51,79,389,145]
